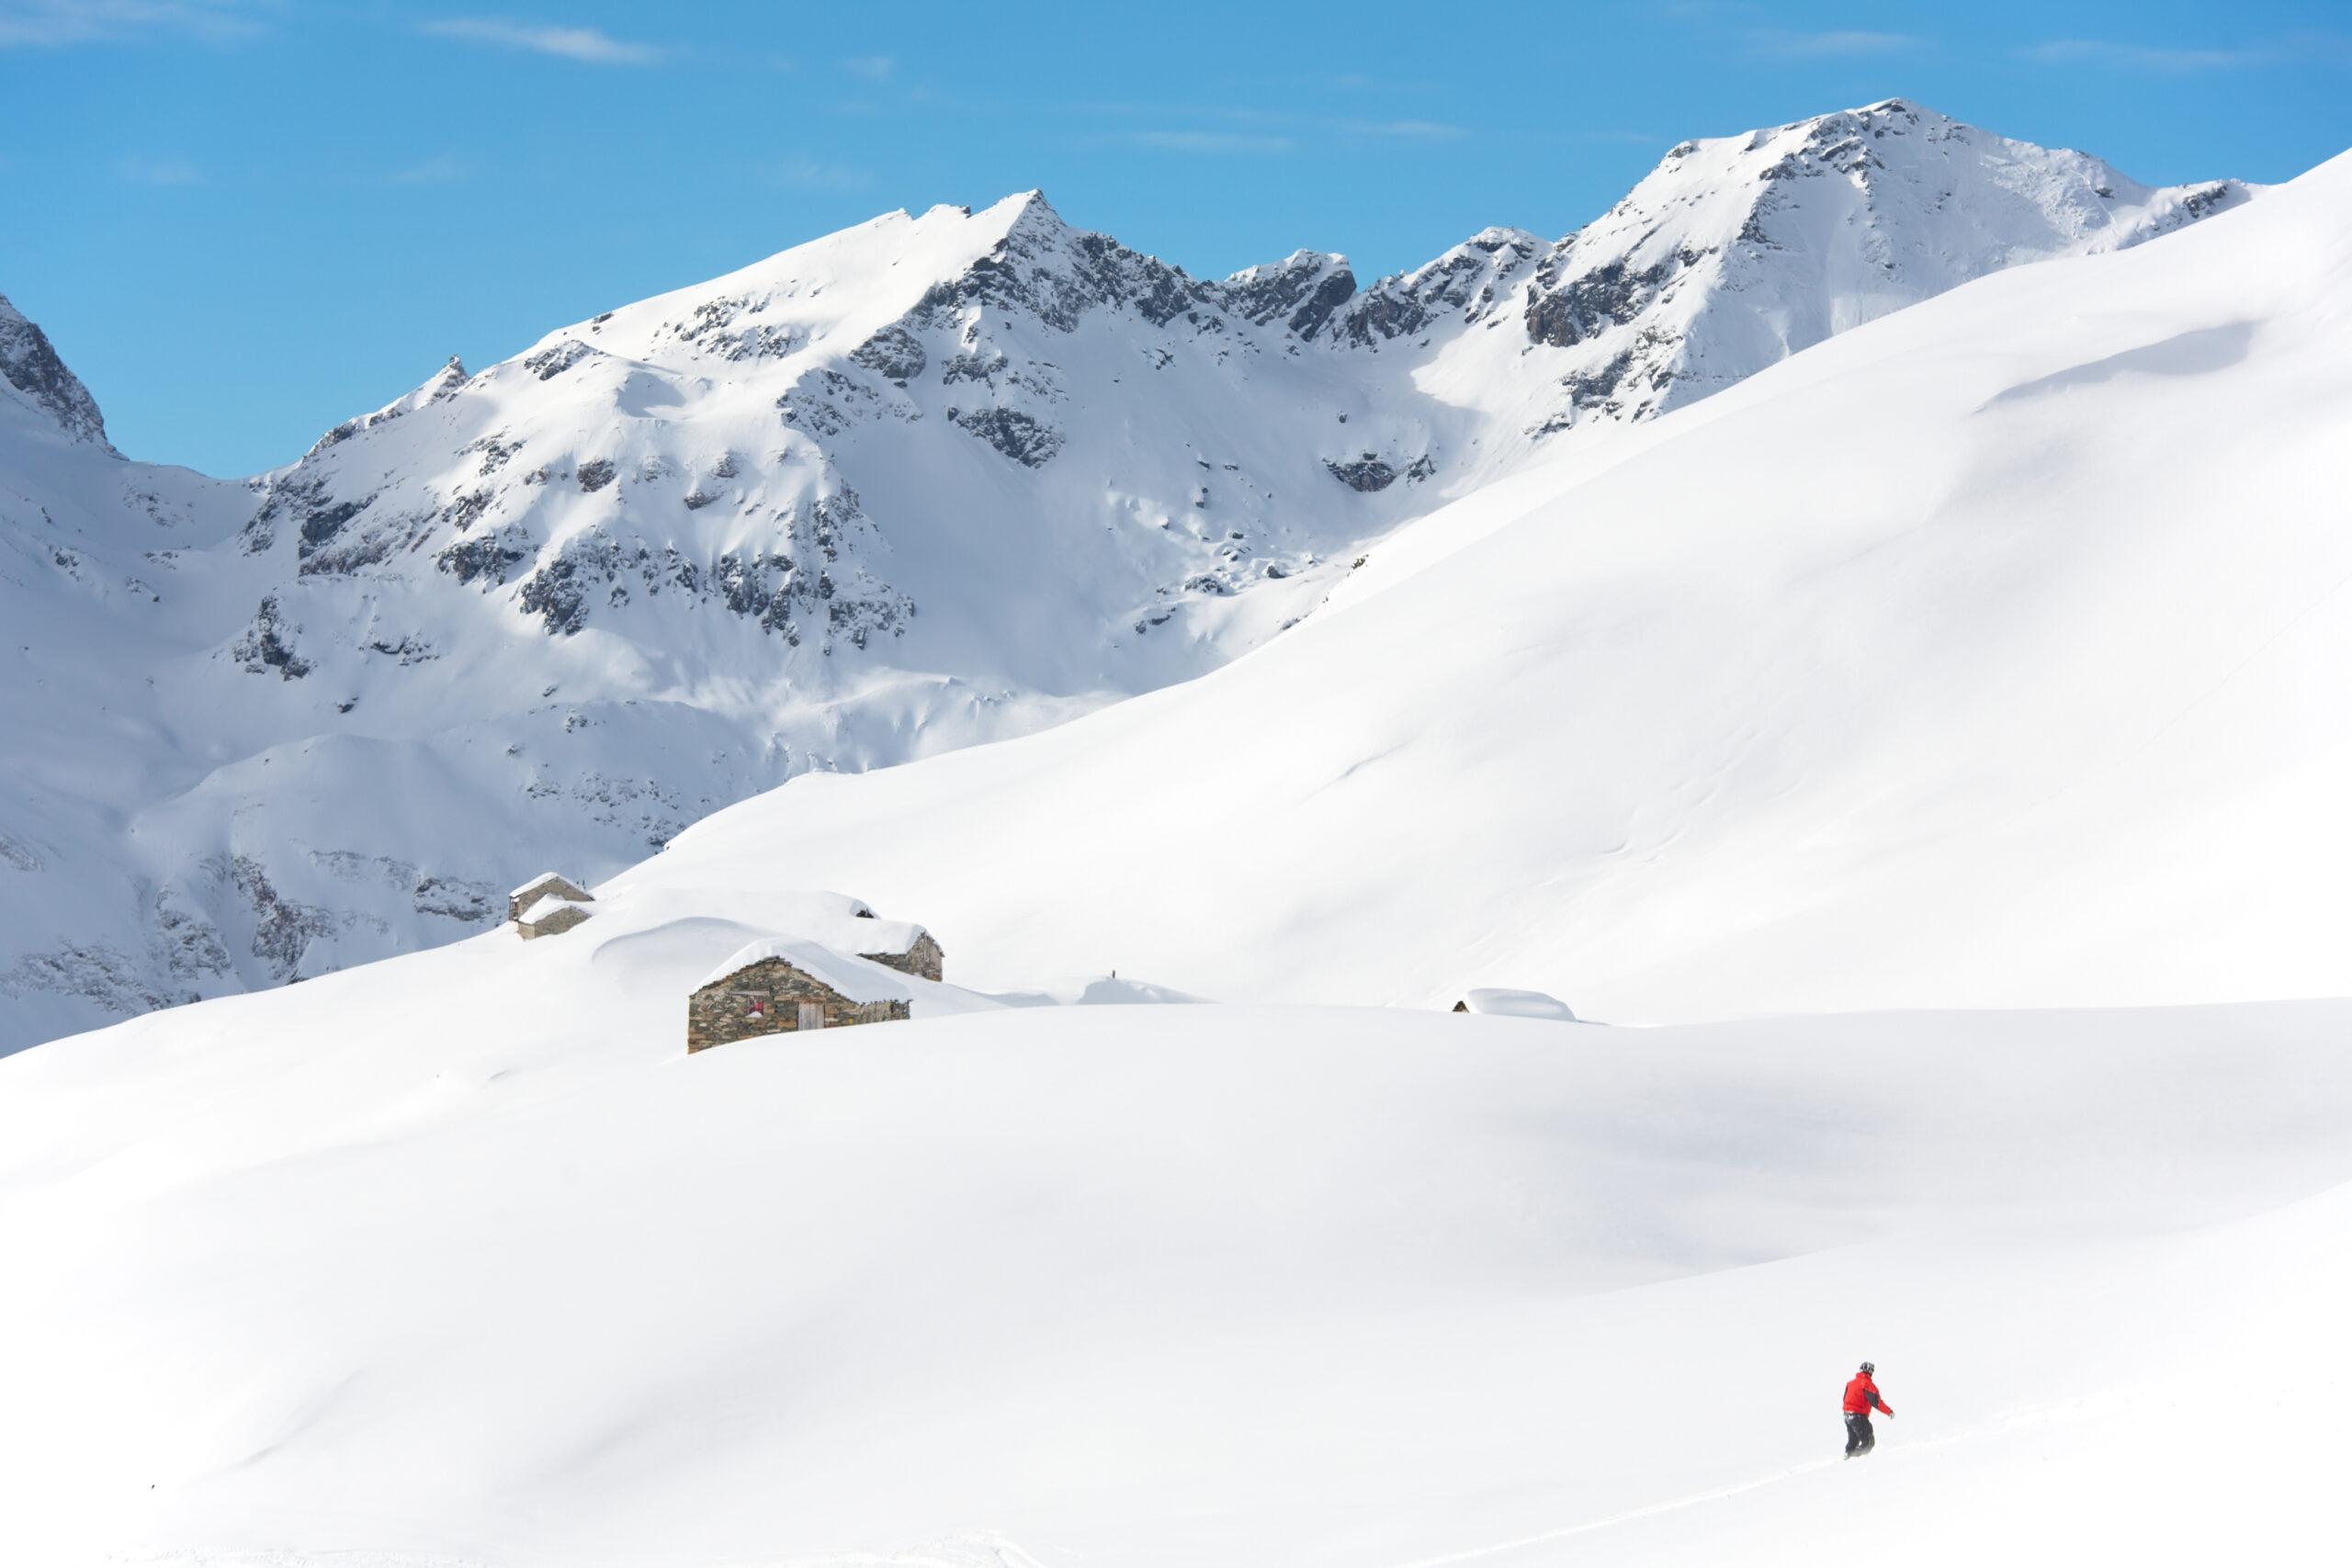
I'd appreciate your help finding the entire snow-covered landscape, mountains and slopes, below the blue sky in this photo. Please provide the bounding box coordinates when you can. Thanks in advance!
[0,92,2352,1568]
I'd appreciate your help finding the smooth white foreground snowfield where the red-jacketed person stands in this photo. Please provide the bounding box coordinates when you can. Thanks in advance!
[0,879,2352,1568]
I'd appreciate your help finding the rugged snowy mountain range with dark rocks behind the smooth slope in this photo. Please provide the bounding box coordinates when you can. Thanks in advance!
[0,101,2246,1048]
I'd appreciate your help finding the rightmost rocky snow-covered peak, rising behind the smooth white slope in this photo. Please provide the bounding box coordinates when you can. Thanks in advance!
[1524,98,2253,430]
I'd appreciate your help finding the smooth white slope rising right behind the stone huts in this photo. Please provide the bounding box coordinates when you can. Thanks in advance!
[623,138,2352,1021]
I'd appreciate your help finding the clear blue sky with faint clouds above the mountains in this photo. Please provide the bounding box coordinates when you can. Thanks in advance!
[0,0,2352,475]
